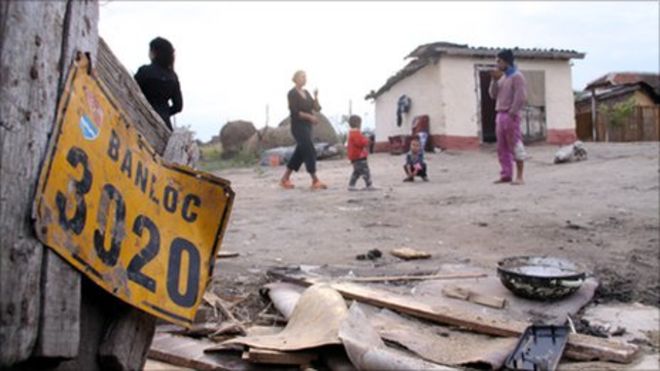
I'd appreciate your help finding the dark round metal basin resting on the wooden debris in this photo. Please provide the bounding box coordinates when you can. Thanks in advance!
[497,256,586,301]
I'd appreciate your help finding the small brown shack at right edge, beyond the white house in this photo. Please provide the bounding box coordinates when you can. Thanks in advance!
[575,72,660,142]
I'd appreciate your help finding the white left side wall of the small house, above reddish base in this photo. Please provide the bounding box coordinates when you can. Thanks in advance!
[375,64,444,142]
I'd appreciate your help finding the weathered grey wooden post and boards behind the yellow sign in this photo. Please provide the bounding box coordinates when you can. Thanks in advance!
[0,0,175,370]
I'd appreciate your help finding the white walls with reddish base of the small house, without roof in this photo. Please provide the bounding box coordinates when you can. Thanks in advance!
[376,55,577,149]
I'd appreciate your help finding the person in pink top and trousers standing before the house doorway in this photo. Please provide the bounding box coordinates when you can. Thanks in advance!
[488,49,527,184]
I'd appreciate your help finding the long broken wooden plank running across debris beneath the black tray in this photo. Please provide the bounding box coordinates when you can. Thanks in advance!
[269,271,639,363]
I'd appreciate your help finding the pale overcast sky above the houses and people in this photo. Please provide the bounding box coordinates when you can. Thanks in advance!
[99,0,660,140]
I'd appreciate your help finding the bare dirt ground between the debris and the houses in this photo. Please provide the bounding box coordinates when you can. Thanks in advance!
[214,143,660,306]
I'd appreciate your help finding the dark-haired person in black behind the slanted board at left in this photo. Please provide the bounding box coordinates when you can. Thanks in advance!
[135,37,183,130]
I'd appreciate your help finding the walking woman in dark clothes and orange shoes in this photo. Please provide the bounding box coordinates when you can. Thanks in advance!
[280,71,328,189]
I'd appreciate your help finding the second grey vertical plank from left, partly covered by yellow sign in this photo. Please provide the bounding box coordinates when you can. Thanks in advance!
[33,1,99,358]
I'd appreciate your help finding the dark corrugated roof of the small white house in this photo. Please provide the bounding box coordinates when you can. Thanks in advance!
[365,41,585,99]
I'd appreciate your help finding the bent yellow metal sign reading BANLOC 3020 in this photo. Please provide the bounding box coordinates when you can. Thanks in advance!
[35,59,234,327]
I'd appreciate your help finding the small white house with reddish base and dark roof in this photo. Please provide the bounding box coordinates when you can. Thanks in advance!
[366,42,584,151]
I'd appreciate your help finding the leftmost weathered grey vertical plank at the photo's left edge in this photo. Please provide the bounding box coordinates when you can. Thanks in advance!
[0,1,67,368]
